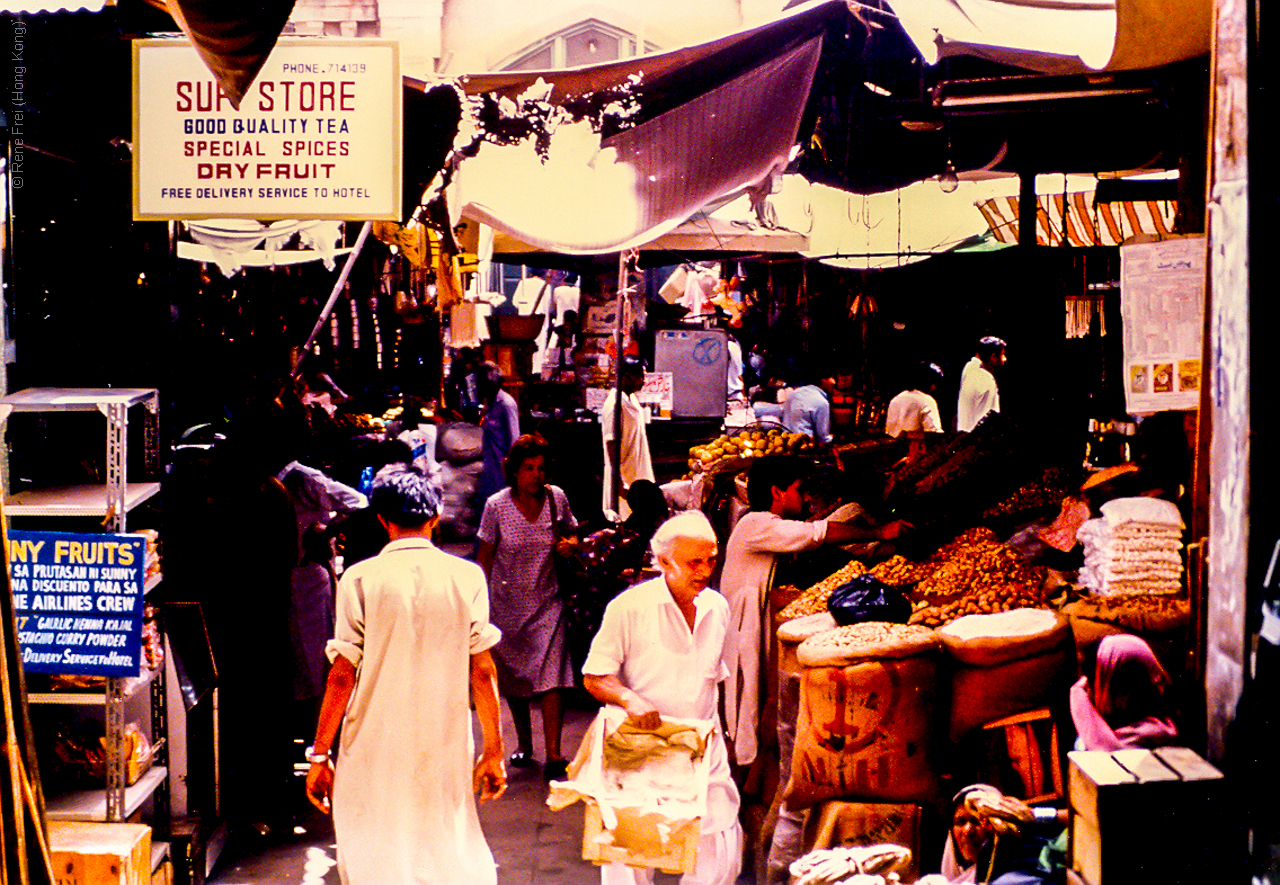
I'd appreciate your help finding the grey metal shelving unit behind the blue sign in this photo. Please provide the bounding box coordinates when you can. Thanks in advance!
[0,387,169,832]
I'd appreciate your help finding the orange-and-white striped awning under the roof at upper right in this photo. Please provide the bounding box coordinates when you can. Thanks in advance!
[977,191,1176,246]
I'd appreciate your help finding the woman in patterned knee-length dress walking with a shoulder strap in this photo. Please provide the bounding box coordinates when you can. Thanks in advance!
[476,434,577,780]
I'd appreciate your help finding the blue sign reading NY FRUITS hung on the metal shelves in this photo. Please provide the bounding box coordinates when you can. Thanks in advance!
[8,532,146,676]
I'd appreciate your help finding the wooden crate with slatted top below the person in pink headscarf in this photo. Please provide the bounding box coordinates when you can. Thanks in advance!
[1066,747,1228,885]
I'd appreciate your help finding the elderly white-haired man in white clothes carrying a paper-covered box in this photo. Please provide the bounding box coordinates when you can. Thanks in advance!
[582,510,742,885]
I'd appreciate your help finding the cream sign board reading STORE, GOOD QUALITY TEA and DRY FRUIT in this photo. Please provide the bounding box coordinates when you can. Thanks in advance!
[133,38,403,222]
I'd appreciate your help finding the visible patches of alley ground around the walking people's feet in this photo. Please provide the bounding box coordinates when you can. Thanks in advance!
[207,699,645,885]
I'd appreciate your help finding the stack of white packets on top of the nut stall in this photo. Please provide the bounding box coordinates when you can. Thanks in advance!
[1076,498,1183,596]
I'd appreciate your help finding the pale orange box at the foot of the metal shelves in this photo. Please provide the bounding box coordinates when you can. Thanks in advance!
[49,821,151,885]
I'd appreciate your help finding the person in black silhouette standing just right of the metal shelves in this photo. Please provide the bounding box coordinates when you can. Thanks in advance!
[179,398,295,839]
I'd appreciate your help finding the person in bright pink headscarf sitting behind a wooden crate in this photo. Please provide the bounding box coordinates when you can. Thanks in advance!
[1070,633,1178,751]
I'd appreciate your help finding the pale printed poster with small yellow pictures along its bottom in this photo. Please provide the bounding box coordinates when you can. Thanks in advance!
[1120,237,1207,415]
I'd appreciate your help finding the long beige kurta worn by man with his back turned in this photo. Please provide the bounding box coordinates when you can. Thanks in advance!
[328,539,502,885]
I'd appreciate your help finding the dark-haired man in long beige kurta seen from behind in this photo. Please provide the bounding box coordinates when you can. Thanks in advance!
[307,465,507,885]
